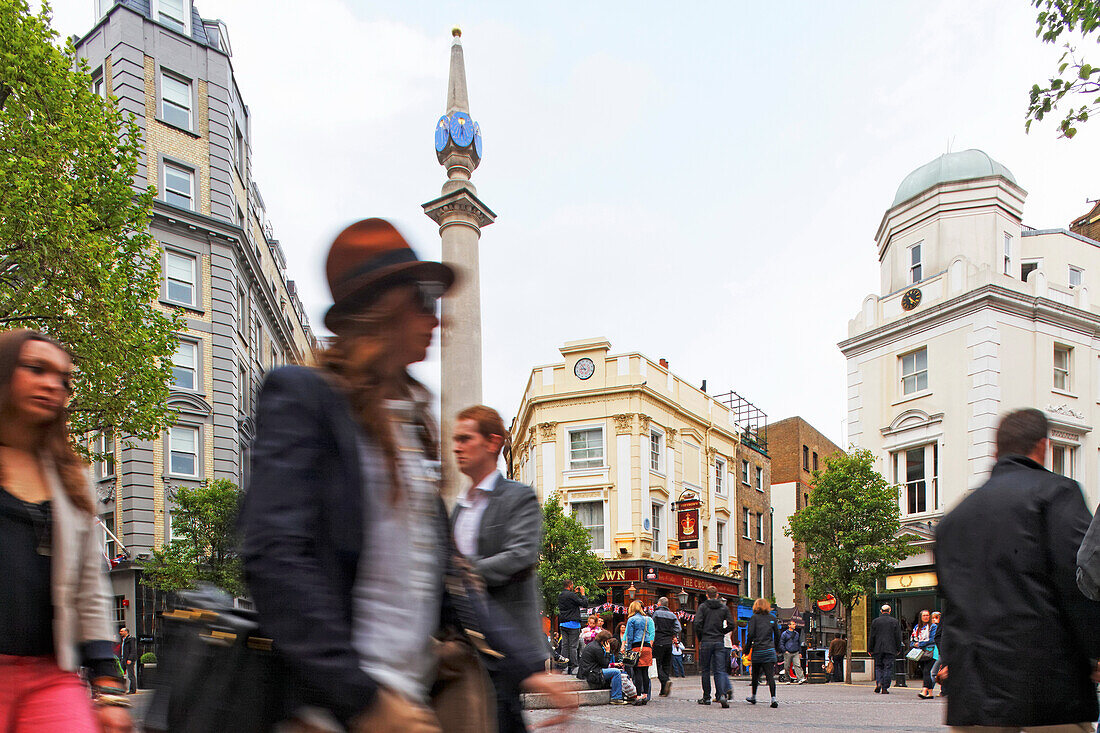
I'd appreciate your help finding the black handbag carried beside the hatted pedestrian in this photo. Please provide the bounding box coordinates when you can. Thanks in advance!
[145,586,288,733]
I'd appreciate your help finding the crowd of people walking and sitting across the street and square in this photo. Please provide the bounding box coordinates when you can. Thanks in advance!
[0,214,1100,733]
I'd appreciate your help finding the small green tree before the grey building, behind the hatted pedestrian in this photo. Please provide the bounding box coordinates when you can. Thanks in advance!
[142,479,245,595]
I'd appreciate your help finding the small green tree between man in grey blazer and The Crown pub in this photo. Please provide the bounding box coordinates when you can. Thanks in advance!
[539,494,604,616]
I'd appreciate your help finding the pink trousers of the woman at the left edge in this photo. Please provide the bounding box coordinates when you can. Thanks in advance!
[0,654,99,733]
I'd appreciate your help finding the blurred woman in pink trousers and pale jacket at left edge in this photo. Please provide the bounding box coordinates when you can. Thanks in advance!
[0,330,131,733]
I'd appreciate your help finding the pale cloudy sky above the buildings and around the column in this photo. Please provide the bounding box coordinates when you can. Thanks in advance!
[38,0,1100,445]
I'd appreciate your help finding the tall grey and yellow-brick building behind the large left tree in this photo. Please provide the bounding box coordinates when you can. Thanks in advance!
[74,0,315,639]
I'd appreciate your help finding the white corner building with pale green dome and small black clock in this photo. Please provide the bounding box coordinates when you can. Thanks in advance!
[839,150,1100,619]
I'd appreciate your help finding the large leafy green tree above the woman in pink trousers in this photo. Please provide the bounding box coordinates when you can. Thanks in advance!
[0,0,183,439]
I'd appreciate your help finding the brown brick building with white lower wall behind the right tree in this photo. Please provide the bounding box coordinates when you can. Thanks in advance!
[768,417,840,611]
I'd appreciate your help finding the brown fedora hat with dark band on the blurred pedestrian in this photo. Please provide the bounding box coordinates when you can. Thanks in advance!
[325,219,454,331]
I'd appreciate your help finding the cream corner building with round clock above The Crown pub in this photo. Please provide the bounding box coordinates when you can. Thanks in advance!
[513,339,772,595]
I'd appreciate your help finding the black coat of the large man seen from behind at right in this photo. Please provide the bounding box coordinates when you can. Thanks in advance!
[936,456,1100,727]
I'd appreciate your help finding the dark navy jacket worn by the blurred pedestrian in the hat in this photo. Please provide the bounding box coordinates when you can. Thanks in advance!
[240,367,546,721]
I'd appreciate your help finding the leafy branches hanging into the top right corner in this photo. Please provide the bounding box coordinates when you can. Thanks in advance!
[1024,0,1100,138]
